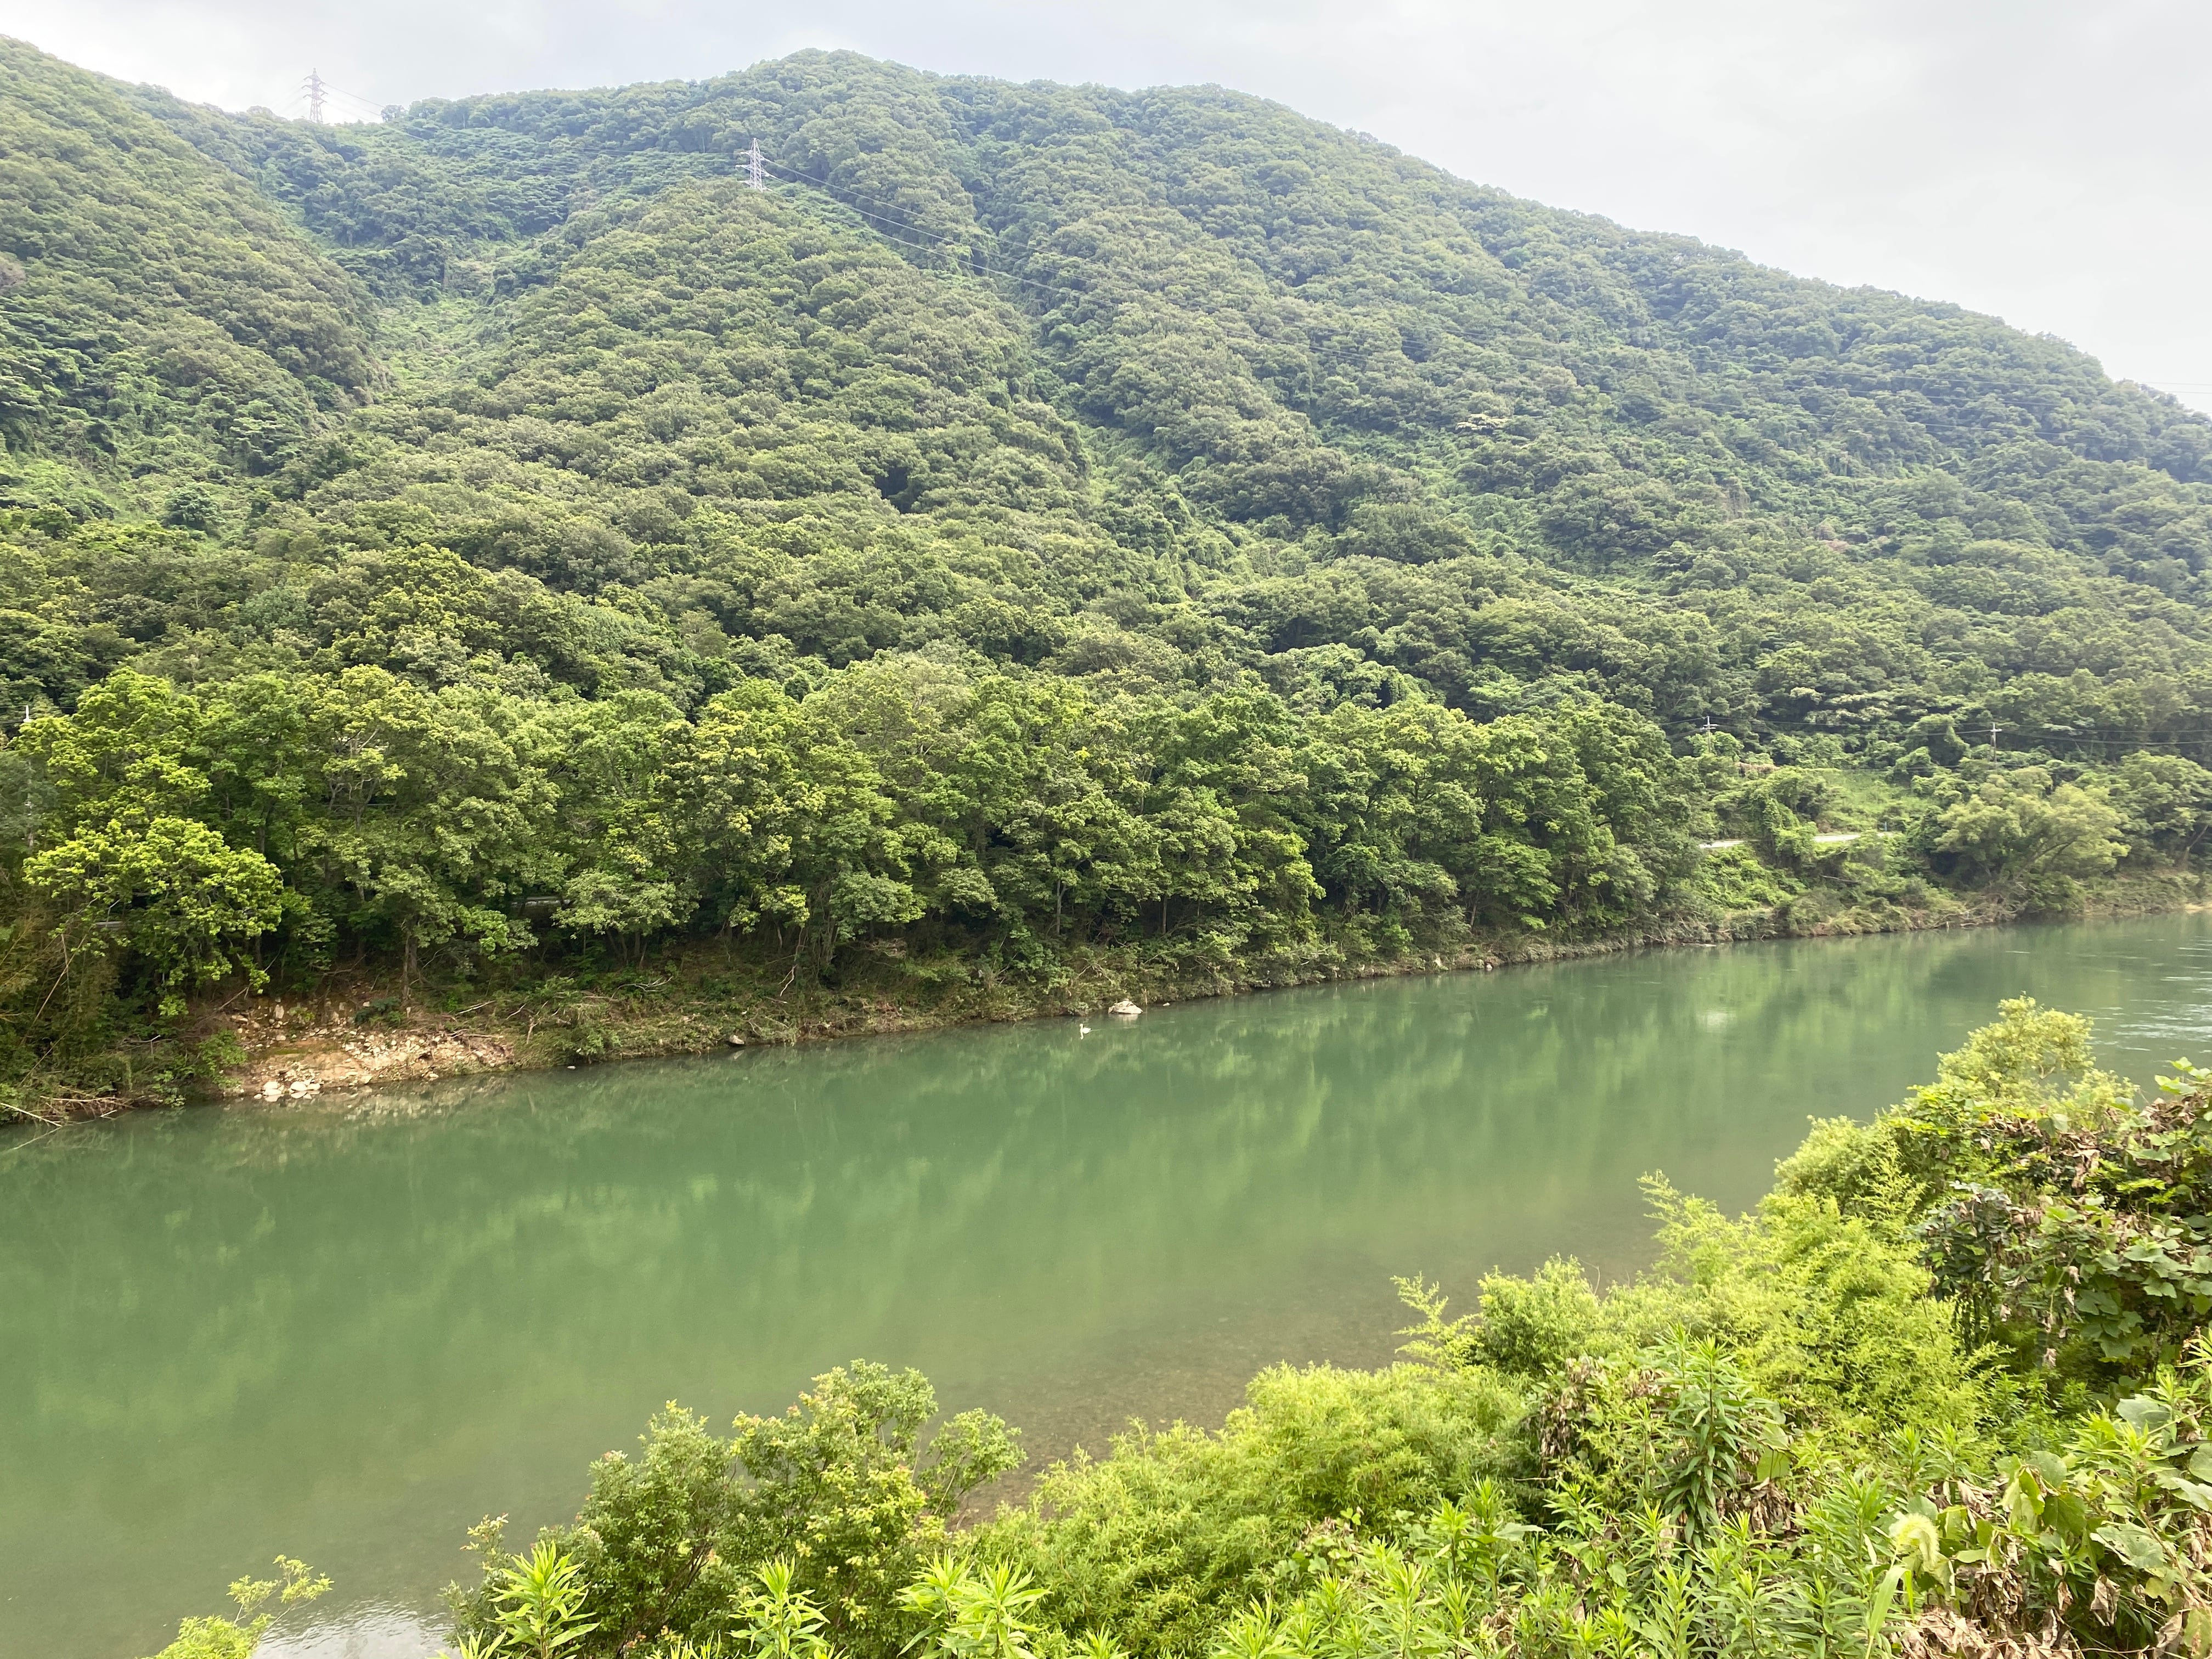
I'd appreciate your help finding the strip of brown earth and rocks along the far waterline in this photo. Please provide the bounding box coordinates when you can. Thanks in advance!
[74,872,2176,1117]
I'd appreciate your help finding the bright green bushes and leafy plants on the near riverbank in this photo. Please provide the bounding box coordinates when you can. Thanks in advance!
[147,1000,2212,1659]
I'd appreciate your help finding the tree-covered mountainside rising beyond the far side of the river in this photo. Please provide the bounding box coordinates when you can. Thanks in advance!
[0,40,2212,1102]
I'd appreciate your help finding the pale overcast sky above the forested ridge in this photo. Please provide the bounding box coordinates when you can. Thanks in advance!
[0,0,2212,409]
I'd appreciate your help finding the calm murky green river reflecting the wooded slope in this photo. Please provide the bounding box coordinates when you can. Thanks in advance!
[13,916,2212,1659]
